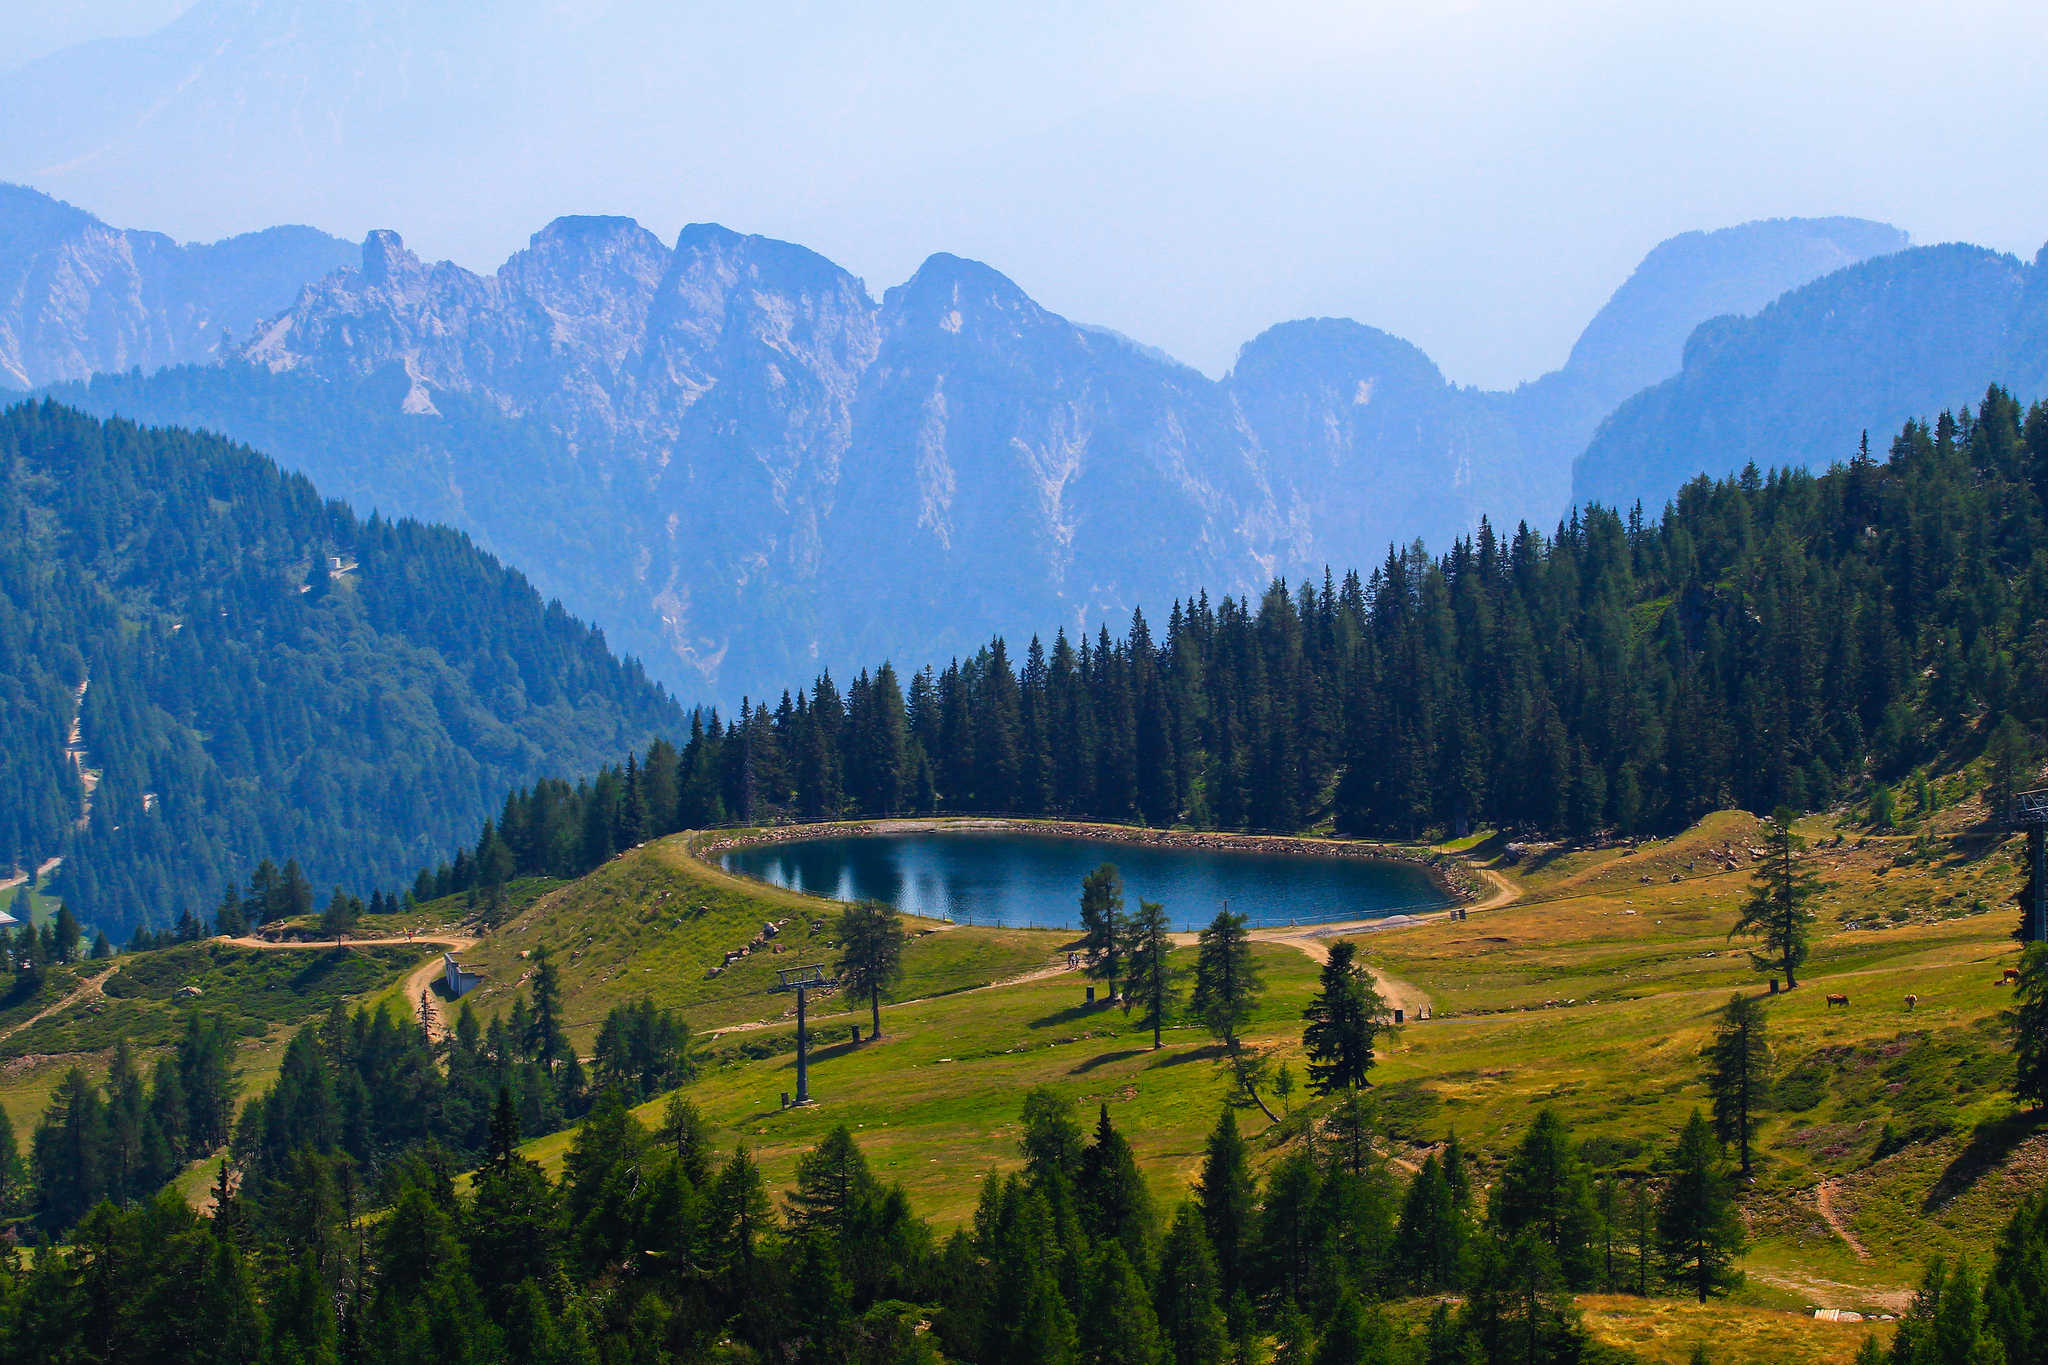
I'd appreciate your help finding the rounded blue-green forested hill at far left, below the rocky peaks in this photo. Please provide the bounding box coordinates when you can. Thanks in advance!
[0,403,680,937]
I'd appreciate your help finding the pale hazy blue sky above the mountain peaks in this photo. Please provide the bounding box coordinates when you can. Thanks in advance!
[0,0,2048,387]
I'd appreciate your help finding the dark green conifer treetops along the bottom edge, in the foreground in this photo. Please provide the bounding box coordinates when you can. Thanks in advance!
[0,1064,2048,1365]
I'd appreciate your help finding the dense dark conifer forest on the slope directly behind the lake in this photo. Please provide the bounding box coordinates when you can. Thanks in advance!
[418,389,2048,894]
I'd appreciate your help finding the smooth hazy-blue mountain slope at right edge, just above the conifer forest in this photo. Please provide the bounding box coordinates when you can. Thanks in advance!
[1573,244,2048,508]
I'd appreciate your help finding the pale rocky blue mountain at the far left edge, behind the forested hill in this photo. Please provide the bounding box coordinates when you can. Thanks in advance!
[0,184,356,389]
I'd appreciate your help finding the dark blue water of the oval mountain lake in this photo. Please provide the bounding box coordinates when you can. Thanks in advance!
[719,831,1450,929]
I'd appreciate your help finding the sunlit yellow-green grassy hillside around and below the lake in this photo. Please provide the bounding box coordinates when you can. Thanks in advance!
[440,804,2048,1361]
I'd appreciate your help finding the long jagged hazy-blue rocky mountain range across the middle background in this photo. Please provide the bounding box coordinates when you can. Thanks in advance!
[0,194,1907,700]
